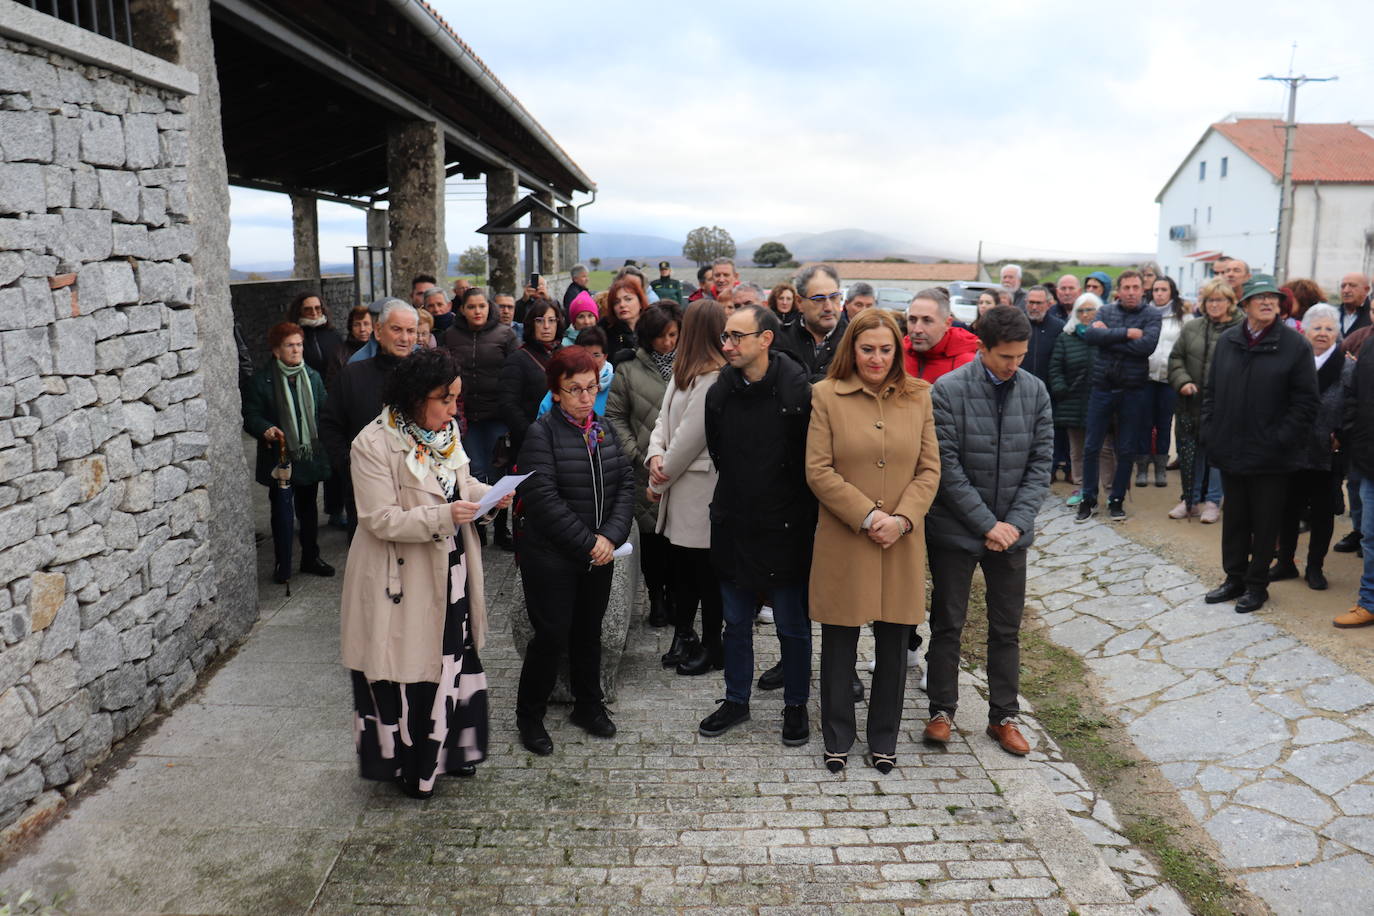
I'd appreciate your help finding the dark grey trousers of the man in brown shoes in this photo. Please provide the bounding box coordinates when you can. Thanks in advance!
[926,547,1026,722]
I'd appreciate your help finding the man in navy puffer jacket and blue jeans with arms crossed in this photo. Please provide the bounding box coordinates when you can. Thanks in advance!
[1077,271,1160,522]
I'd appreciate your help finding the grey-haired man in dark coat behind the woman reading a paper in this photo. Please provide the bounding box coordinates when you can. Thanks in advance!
[320,299,420,537]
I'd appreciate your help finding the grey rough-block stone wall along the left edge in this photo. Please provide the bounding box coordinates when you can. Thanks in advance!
[0,32,214,827]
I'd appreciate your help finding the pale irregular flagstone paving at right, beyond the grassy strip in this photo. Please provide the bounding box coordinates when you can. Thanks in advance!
[1028,505,1374,915]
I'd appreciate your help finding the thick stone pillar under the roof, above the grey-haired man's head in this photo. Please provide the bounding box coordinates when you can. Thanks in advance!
[386,121,448,299]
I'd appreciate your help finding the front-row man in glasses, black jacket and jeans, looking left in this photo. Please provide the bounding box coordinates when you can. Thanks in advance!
[698,302,813,746]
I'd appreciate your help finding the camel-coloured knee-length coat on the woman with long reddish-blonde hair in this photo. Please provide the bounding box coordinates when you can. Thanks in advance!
[807,378,940,626]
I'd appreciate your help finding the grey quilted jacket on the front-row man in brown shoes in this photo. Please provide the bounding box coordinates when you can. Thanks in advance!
[926,360,1054,555]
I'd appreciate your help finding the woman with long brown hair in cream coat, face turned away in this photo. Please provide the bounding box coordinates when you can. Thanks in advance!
[644,299,725,674]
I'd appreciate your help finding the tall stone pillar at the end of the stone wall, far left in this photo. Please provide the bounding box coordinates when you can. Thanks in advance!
[147,0,258,651]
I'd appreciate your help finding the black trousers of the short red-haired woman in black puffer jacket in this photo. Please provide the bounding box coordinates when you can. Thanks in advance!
[515,551,614,721]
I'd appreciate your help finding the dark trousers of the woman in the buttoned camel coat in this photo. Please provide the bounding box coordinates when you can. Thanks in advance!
[820,621,915,754]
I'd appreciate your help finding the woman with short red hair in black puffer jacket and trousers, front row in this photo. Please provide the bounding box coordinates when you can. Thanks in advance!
[515,346,635,755]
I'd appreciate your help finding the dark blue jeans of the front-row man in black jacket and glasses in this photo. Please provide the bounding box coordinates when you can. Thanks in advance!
[720,582,811,706]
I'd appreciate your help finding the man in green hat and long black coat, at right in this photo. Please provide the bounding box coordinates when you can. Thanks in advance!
[1200,273,1319,614]
